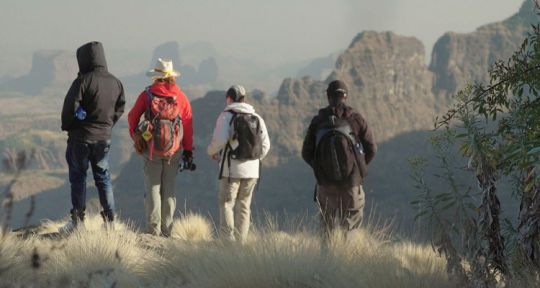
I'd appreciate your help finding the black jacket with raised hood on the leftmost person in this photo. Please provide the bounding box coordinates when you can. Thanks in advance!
[62,42,126,142]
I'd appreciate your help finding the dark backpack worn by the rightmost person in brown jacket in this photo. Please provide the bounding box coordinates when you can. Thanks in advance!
[313,115,366,185]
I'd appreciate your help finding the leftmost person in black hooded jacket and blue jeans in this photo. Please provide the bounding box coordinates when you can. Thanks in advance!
[60,42,125,232]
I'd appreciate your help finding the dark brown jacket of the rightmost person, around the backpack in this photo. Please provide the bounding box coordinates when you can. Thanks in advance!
[302,103,377,186]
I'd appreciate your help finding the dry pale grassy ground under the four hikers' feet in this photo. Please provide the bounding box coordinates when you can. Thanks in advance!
[0,214,453,287]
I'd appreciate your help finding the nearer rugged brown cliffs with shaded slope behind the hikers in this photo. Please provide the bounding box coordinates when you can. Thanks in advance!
[2,2,539,227]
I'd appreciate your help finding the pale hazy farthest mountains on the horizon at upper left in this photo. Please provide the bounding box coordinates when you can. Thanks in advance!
[0,41,335,99]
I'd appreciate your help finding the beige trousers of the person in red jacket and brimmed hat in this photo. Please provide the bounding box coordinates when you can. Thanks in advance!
[143,153,180,237]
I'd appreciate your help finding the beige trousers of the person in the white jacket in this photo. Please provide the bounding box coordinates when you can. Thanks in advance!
[219,178,258,243]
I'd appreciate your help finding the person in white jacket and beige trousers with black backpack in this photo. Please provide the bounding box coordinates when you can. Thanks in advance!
[207,85,270,242]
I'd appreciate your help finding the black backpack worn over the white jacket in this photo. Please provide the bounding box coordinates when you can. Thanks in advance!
[219,110,262,179]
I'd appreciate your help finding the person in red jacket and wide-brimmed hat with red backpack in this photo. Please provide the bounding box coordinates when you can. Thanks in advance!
[128,59,194,237]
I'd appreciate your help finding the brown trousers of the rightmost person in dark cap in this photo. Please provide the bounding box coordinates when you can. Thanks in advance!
[317,186,365,240]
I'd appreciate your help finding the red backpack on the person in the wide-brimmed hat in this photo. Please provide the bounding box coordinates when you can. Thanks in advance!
[145,88,184,159]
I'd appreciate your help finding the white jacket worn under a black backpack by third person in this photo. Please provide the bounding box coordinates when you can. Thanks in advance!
[207,102,270,178]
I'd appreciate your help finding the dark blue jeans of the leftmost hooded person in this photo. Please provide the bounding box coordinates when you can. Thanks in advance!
[66,140,114,211]
